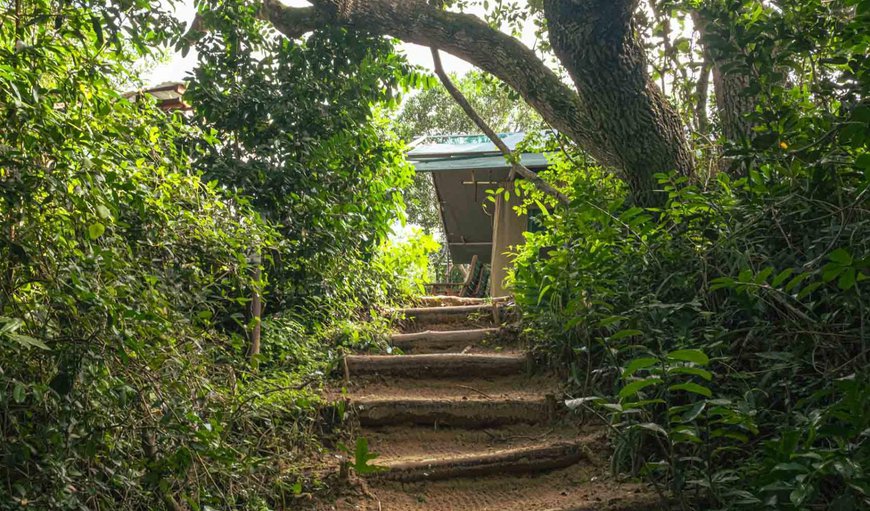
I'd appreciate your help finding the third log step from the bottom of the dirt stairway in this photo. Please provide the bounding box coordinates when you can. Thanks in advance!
[345,353,529,378]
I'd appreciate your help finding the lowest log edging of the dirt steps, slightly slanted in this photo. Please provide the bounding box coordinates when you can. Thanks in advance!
[372,441,589,481]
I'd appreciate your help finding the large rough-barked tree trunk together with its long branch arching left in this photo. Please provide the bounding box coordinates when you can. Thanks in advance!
[263,0,693,204]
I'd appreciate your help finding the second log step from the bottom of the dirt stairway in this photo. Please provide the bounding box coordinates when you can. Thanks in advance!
[352,397,556,428]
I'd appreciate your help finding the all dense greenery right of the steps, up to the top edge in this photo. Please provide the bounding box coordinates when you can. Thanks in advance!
[514,2,870,510]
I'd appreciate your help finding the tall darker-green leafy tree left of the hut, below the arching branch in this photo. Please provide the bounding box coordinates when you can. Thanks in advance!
[189,2,416,319]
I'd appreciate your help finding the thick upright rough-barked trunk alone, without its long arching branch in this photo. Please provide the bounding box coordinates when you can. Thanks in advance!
[544,0,694,203]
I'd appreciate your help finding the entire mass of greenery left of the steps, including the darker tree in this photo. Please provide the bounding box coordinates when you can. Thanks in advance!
[0,1,433,509]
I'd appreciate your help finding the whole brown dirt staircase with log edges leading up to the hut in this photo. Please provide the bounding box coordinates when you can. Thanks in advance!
[333,299,657,511]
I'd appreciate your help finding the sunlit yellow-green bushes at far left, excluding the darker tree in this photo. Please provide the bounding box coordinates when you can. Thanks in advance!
[0,2,356,510]
